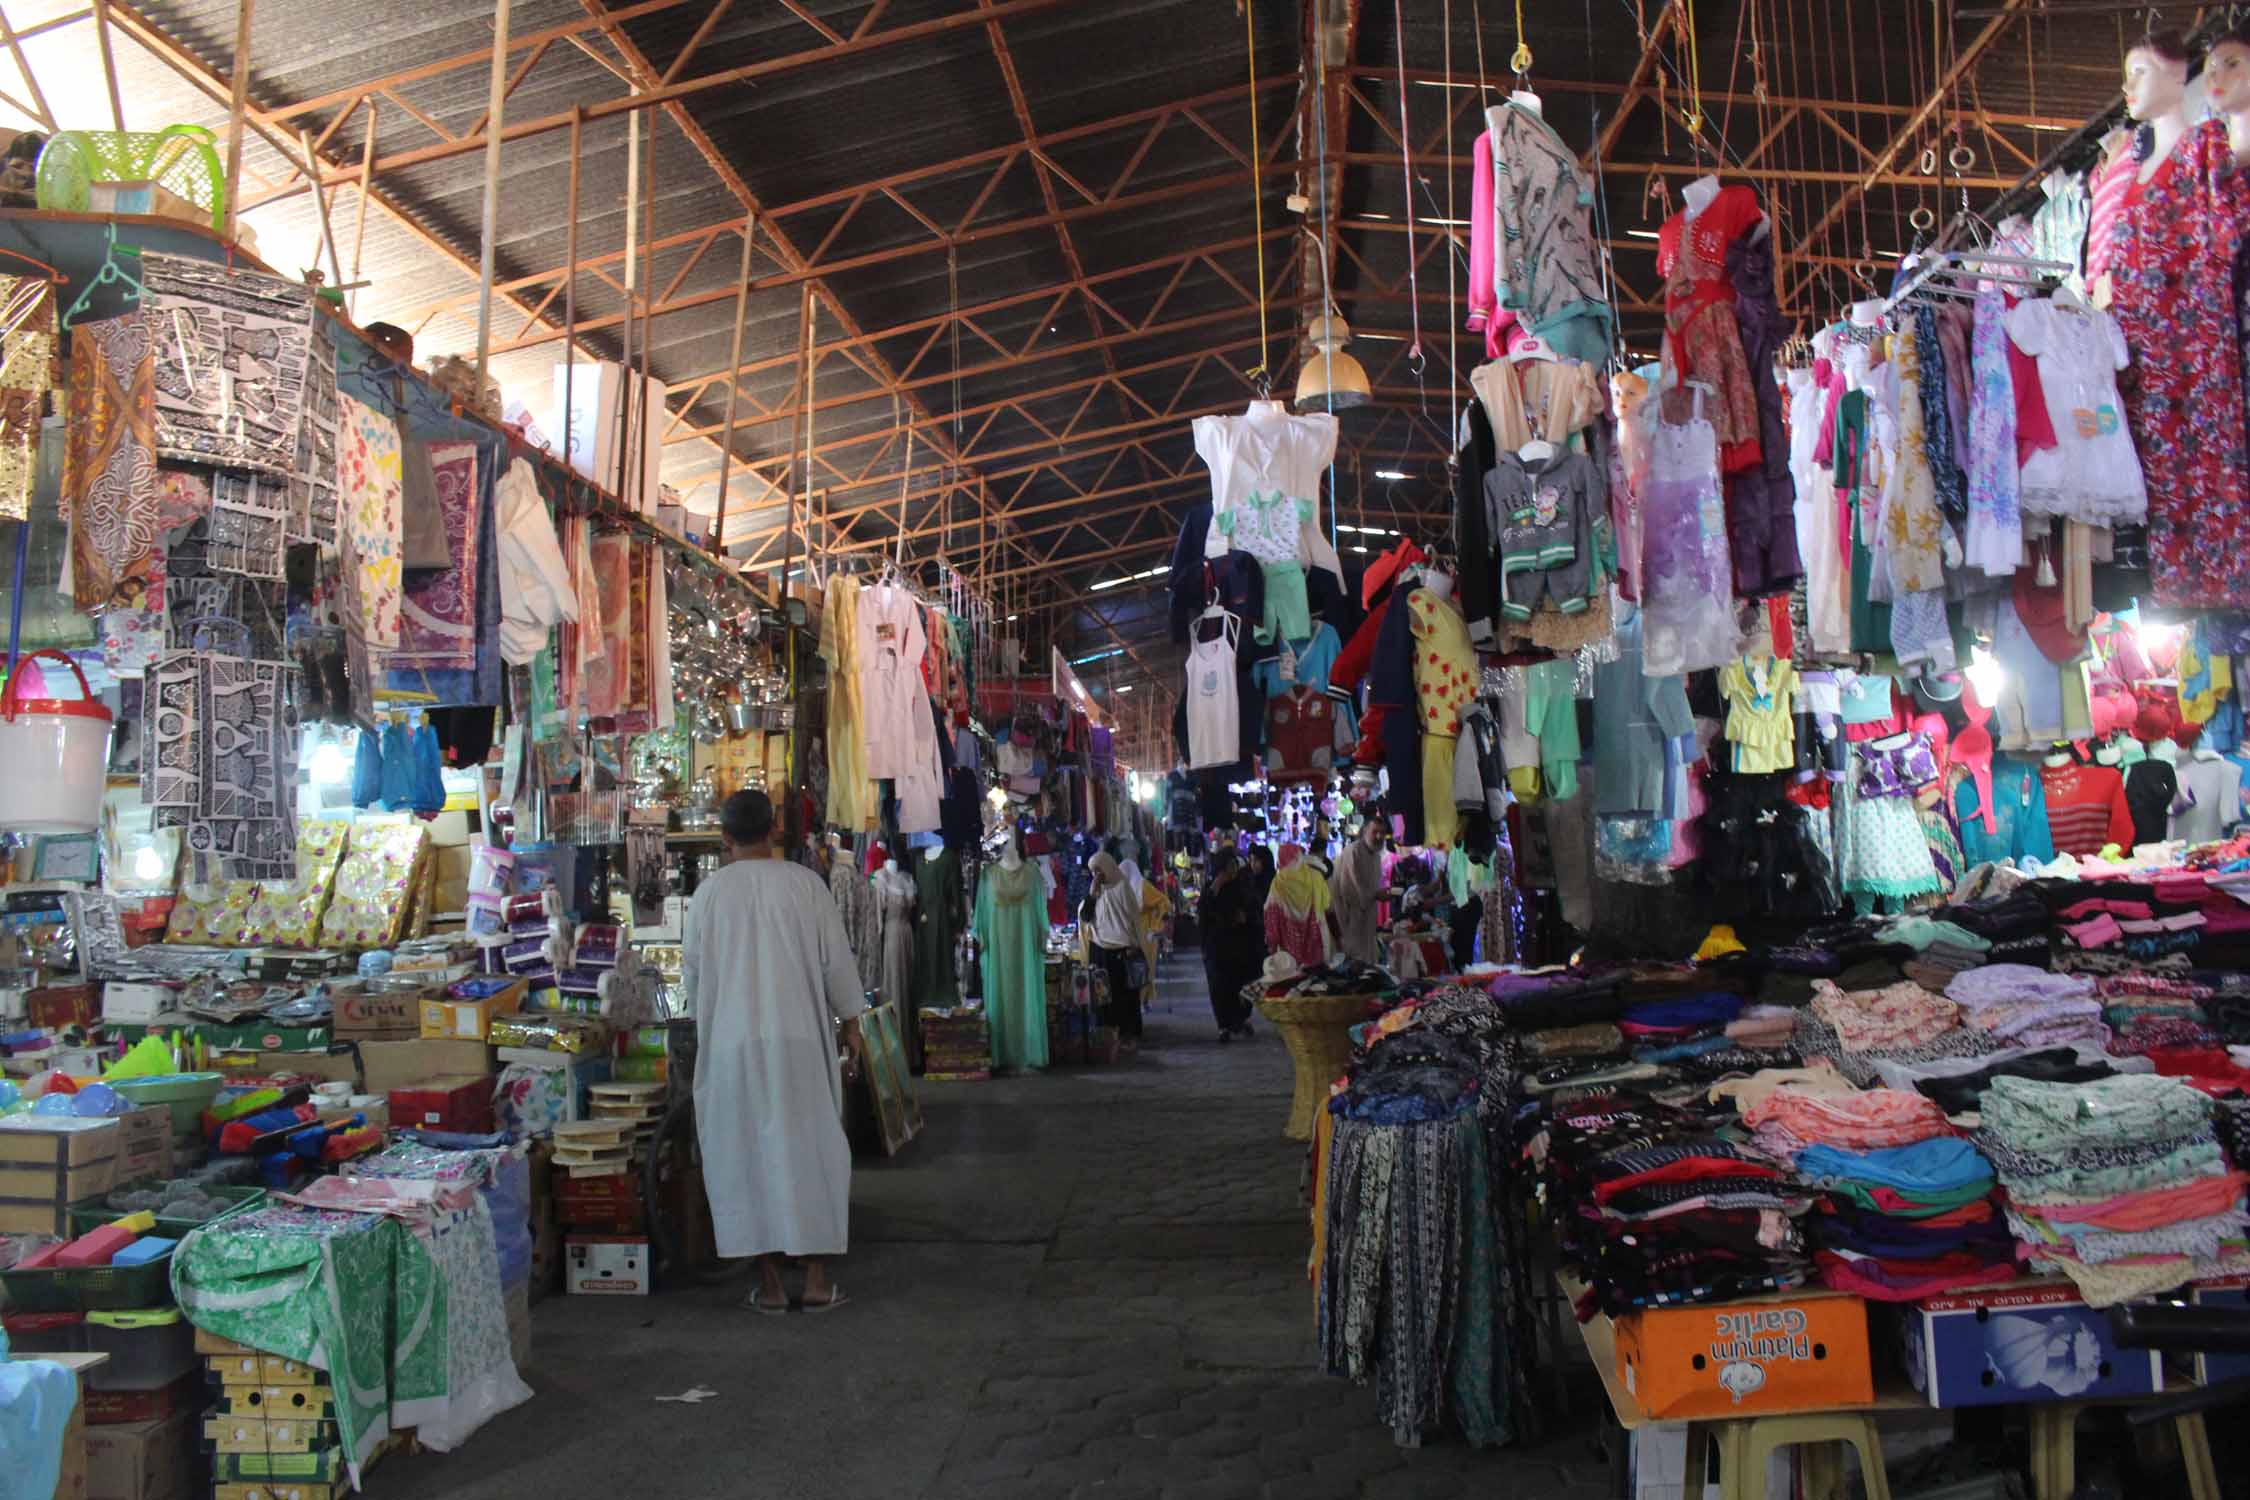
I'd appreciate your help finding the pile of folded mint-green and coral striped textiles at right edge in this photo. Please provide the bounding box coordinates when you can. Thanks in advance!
[1978,1075,2250,1307]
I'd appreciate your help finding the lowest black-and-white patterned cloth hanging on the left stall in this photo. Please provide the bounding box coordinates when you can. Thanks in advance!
[142,652,297,879]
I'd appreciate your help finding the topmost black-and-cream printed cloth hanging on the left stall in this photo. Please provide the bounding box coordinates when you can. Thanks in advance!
[142,252,313,479]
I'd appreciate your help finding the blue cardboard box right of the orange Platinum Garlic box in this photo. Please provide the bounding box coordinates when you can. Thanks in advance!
[1895,1280,2165,1406]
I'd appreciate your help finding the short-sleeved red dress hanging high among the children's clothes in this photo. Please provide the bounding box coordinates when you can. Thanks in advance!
[1656,187,1771,475]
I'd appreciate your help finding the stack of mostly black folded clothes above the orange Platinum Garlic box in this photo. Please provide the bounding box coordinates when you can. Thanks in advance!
[1546,1093,1811,1320]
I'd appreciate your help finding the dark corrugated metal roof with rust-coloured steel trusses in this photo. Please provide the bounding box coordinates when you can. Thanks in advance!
[11,0,2133,674]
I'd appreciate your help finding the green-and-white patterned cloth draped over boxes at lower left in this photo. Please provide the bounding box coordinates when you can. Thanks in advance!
[171,1203,398,1482]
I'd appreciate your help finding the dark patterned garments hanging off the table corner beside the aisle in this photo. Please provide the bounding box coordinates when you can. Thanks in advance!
[1314,985,1537,1446]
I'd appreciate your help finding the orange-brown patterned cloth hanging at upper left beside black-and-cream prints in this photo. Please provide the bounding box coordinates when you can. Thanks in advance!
[63,310,158,609]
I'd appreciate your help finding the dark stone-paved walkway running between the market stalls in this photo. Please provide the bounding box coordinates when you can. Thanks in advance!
[369,956,1613,1500]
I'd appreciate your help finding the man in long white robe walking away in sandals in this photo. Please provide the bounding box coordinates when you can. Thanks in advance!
[680,792,866,1313]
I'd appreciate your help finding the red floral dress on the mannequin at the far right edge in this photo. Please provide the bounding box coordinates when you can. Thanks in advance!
[2108,119,2250,609]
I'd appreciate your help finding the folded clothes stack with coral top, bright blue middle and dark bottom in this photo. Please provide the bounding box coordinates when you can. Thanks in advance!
[1733,1070,2016,1302]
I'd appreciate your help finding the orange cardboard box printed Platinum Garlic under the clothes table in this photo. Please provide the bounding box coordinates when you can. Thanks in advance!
[1616,1289,1874,1421]
